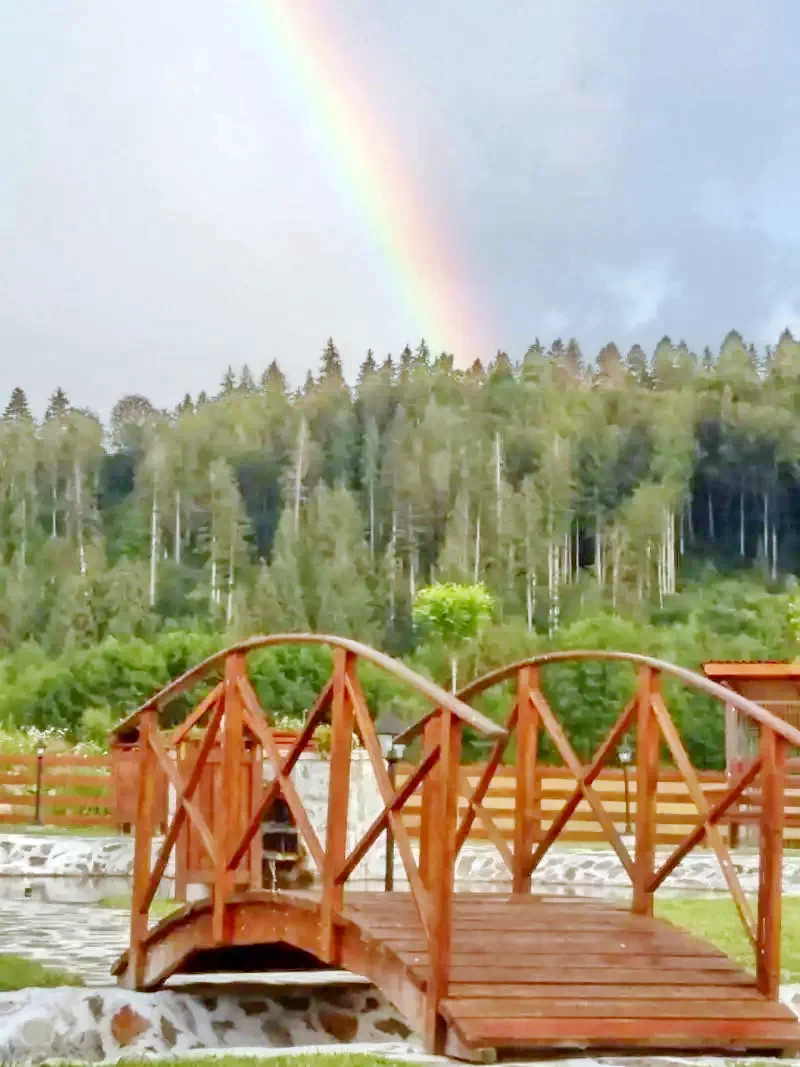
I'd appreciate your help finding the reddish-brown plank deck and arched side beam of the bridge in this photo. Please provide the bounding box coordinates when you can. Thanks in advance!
[115,891,800,1060]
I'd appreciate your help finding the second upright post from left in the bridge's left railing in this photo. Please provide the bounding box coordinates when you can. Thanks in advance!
[211,652,249,944]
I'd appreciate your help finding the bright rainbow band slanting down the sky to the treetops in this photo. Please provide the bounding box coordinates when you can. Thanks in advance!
[249,0,494,365]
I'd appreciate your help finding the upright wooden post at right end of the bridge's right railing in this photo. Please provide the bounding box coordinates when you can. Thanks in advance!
[756,726,786,1000]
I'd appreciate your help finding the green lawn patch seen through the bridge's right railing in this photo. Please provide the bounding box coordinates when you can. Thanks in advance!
[655,896,800,982]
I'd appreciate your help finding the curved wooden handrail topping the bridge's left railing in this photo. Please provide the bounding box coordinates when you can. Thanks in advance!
[111,634,505,740]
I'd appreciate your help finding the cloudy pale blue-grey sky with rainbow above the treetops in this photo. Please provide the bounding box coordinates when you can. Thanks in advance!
[0,0,800,417]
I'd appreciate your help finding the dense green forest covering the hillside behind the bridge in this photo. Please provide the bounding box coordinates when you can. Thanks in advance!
[0,331,800,759]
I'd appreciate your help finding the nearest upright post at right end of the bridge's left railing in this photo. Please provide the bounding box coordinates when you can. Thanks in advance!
[425,710,462,1055]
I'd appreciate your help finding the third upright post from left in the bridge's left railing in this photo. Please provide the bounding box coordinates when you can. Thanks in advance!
[320,649,355,964]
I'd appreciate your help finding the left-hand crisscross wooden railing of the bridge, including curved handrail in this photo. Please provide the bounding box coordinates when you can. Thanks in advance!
[115,634,506,1039]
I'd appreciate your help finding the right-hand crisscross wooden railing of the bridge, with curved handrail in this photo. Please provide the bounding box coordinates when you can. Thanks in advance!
[441,651,800,998]
